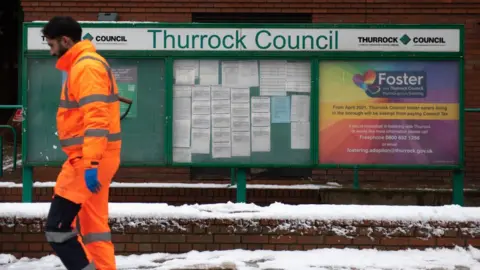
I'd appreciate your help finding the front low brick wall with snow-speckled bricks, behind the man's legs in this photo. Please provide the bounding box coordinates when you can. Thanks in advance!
[0,217,480,258]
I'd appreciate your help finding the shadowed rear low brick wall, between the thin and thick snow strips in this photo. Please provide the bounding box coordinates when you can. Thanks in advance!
[0,187,480,206]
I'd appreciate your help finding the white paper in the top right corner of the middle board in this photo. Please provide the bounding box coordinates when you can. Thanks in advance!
[287,62,311,93]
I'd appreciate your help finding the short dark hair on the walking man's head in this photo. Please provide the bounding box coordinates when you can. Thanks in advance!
[42,16,82,42]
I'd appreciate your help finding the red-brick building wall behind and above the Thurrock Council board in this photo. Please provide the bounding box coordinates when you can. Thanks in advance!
[16,0,480,187]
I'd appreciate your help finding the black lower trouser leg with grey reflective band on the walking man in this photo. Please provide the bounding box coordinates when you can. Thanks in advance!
[45,195,95,270]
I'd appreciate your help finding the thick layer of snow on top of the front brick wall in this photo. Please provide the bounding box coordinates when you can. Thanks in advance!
[0,202,480,222]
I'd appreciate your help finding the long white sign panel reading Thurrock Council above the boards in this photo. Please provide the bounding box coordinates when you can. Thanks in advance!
[28,27,460,52]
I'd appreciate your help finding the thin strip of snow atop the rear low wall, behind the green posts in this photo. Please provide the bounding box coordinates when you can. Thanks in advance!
[0,182,341,190]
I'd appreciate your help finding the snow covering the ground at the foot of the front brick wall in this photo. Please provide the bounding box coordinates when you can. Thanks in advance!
[0,247,480,270]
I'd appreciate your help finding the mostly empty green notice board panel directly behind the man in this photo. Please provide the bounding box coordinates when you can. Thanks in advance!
[26,58,166,165]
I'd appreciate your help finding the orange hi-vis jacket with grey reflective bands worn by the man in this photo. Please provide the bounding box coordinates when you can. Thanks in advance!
[56,40,121,168]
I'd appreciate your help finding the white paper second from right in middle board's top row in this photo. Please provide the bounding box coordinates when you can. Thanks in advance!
[260,60,287,96]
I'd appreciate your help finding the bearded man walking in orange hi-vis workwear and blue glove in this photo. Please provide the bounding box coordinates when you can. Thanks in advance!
[42,16,121,270]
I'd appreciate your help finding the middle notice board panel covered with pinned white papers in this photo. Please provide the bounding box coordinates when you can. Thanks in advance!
[172,59,312,166]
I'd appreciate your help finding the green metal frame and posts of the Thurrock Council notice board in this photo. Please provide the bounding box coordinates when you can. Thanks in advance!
[21,22,464,205]
